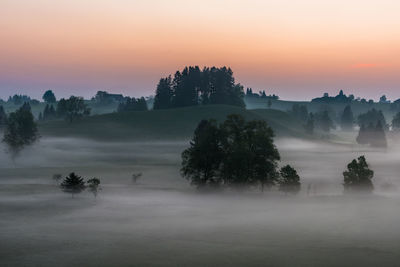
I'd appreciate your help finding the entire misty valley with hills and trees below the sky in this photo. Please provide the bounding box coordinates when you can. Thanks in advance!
[0,67,400,266]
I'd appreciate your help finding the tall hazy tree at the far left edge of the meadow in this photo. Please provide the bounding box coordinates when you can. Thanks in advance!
[3,106,39,159]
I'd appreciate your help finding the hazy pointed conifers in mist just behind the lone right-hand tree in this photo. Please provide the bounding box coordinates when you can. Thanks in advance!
[356,120,387,147]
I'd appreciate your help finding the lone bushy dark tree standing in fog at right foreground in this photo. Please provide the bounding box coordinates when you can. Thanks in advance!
[343,156,374,192]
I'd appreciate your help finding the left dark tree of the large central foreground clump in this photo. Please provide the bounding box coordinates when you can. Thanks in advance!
[181,120,223,188]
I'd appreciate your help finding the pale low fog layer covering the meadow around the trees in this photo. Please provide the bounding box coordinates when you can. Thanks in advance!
[0,138,400,266]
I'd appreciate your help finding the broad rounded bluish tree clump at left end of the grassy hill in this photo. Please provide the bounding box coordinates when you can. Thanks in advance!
[56,96,90,122]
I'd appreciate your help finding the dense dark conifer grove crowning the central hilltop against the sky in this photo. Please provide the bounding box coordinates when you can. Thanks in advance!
[154,66,245,109]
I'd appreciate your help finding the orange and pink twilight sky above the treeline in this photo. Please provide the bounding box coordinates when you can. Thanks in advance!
[0,0,400,100]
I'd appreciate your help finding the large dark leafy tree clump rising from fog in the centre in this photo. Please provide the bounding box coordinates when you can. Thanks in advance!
[181,115,297,194]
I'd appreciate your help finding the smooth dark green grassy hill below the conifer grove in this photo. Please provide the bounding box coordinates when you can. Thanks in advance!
[39,105,304,141]
